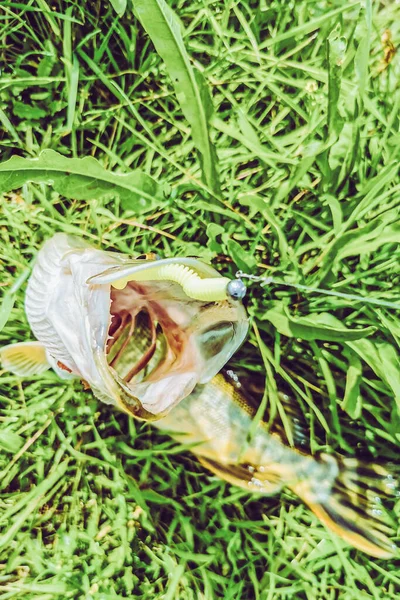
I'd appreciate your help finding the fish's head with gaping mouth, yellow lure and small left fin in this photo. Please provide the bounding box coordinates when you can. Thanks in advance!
[0,233,248,421]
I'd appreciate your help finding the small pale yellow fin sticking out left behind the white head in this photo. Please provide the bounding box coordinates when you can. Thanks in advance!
[0,342,50,377]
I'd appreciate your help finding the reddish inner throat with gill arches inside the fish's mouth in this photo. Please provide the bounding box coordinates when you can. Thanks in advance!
[106,282,200,403]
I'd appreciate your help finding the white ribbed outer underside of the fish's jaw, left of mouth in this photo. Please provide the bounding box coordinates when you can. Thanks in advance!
[25,233,123,404]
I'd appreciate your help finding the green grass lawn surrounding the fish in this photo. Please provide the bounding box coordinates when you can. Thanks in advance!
[0,0,400,600]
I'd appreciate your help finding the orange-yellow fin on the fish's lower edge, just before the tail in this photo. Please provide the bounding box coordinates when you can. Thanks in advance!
[197,456,285,495]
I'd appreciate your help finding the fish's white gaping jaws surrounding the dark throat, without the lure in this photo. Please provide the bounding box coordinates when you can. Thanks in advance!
[25,234,248,420]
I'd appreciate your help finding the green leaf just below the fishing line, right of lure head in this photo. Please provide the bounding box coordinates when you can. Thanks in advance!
[262,301,376,342]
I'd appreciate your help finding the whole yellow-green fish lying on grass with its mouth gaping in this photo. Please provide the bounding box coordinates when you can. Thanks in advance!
[0,234,399,558]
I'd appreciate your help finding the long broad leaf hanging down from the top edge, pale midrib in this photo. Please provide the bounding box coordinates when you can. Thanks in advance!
[134,0,219,193]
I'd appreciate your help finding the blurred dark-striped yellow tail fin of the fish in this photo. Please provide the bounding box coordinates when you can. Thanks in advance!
[290,454,399,558]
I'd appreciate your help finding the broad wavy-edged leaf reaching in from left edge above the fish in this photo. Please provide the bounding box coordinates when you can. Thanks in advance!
[0,150,165,213]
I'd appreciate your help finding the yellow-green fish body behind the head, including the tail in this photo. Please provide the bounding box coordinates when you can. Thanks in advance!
[153,373,399,558]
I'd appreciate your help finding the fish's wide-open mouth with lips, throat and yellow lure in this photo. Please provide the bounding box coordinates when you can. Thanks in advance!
[88,259,248,420]
